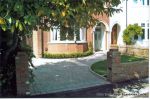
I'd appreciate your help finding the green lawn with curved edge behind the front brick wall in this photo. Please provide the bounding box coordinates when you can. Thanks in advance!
[91,55,144,76]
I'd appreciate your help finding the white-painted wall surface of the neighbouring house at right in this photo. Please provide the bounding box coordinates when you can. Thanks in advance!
[109,0,150,47]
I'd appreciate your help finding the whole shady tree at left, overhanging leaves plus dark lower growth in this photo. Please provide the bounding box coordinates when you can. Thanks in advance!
[0,0,120,95]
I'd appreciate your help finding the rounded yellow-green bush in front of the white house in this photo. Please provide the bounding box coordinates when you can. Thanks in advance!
[123,24,143,45]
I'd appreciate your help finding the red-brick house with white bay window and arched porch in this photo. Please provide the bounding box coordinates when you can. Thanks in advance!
[32,15,109,57]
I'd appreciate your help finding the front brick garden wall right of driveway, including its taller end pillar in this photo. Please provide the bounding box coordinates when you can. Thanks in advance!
[107,49,149,83]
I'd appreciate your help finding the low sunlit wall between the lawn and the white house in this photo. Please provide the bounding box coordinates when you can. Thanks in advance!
[119,45,149,58]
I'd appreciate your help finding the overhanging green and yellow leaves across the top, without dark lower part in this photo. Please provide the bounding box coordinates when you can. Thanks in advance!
[0,0,120,33]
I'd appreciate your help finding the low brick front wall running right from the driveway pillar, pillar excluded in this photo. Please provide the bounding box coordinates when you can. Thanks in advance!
[111,60,149,82]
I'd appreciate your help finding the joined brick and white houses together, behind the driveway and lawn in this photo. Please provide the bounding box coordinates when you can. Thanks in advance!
[32,0,150,57]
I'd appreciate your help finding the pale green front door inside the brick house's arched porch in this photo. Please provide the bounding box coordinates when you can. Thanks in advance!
[94,26,102,51]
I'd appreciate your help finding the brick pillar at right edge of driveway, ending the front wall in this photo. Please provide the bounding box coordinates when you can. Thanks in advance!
[107,47,122,82]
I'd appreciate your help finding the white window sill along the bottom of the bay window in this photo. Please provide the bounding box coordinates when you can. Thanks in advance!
[48,41,87,44]
